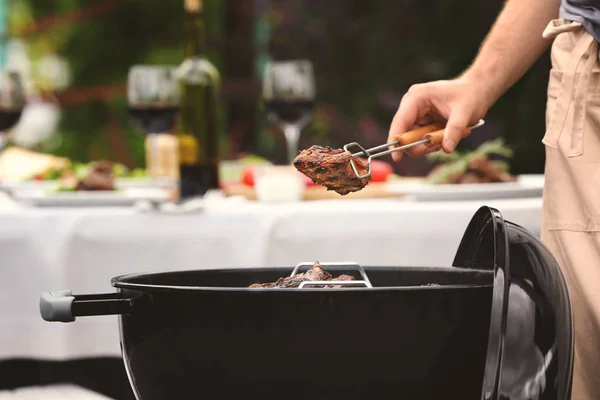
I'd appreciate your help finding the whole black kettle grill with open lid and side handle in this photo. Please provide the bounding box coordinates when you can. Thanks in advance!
[40,207,573,400]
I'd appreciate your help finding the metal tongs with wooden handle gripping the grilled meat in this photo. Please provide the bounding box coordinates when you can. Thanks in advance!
[344,119,485,179]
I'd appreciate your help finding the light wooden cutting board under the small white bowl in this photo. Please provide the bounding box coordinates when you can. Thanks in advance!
[224,182,403,201]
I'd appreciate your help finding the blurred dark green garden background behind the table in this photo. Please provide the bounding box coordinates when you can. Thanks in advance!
[3,0,549,175]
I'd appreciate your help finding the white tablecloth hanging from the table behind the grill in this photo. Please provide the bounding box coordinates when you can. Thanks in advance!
[0,199,541,359]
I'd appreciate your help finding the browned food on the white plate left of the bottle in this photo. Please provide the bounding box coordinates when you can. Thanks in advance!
[58,161,115,192]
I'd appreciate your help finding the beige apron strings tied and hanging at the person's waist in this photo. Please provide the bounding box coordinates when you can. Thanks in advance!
[542,20,598,157]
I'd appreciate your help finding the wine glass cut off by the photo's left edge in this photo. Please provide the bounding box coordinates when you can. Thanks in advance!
[0,70,25,152]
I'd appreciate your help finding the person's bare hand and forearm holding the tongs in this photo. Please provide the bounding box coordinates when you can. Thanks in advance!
[388,0,560,161]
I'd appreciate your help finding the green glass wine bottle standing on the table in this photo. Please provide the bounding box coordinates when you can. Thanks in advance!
[178,0,220,200]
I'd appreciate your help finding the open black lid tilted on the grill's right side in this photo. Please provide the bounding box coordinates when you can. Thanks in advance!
[452,207,573,400]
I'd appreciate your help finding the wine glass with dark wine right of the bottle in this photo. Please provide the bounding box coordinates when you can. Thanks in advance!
[263,60,315,163]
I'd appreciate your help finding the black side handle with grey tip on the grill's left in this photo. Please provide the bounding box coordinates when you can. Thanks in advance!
[40,290,134,322]
